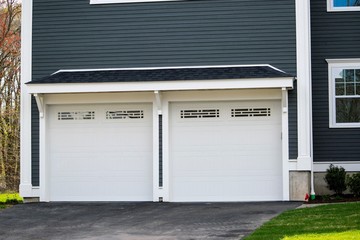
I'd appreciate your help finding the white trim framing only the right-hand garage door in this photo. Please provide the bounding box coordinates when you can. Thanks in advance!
[160,88,289,201]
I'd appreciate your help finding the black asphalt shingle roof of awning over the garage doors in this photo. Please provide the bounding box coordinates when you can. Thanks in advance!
[28,66,293,84]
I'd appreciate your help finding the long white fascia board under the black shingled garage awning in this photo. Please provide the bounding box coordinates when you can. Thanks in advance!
[27,77,293,94]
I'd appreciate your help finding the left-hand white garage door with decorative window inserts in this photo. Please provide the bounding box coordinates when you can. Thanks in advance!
[47,104,152,201]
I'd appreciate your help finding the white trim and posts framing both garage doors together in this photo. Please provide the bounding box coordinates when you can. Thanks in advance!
[37,88,289,202]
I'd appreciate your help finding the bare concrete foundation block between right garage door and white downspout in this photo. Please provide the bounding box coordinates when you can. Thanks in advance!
[290,171,310,201]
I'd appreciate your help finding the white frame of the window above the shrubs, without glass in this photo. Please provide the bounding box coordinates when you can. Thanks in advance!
[326,58,360,128]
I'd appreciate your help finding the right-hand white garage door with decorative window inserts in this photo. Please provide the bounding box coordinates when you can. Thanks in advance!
[170,101,282,201]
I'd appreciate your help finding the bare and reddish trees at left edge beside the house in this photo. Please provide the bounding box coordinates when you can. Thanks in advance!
[0,0,21,191]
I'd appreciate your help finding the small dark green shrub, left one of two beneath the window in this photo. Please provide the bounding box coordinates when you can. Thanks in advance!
[324,164,346,195]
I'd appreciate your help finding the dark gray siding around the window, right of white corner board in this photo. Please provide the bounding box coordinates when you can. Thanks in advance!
[311,0,360,162]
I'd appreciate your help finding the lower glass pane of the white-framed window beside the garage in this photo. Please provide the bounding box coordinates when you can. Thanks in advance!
[336,98,360,123]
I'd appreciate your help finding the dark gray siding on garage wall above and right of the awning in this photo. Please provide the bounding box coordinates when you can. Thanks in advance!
[33,0,297,186]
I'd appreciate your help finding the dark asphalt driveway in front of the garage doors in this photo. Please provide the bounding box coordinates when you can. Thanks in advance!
[0,202,300,240]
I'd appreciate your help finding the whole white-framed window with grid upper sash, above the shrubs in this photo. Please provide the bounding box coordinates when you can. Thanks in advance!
[328,59,360,127]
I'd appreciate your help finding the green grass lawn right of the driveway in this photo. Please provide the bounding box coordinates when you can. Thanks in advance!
[245,203,360,240]
